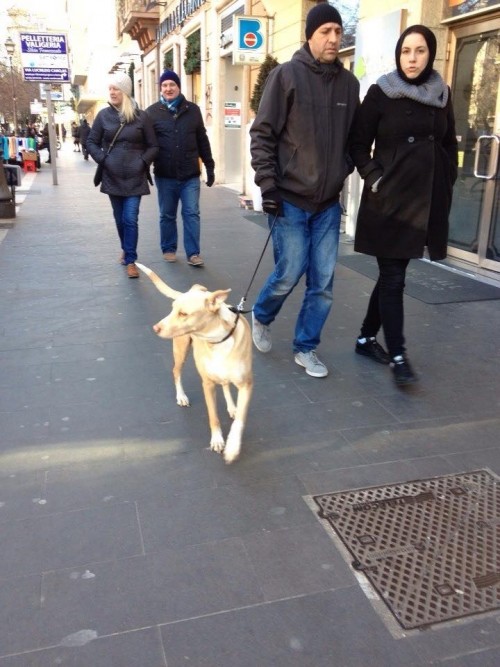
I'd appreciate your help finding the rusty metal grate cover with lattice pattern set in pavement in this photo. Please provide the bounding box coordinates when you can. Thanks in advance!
[313,470,500,630]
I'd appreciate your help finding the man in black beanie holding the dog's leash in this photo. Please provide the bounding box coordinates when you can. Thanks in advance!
[250,2,359,377]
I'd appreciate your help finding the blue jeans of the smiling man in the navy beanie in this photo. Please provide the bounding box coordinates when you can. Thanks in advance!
[155,176,200,258]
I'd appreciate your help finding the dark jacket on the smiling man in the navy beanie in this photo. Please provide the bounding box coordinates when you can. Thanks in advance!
[146,95,215,181]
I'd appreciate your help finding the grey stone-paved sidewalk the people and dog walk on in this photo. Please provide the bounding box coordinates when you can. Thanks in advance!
[0,144,500,667]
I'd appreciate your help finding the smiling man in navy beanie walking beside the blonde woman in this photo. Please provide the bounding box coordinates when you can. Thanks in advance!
[146,70,215,267]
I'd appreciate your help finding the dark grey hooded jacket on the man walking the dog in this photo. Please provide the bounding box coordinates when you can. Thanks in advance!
[250,45,359,212]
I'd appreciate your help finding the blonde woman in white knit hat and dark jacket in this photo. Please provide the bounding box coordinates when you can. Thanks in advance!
[87,73,158,278]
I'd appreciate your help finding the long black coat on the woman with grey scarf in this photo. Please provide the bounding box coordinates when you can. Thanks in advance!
[349,85,457,260]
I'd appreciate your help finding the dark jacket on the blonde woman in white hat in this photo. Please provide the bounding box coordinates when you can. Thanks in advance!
[87,105,158,197]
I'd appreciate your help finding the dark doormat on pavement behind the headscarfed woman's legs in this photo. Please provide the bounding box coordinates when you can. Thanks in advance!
[337,254,500,304]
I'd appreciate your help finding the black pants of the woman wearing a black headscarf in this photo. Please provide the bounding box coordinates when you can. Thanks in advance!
[361,257,410,357]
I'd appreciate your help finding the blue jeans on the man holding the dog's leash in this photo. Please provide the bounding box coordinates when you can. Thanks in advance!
[253,202,341,352]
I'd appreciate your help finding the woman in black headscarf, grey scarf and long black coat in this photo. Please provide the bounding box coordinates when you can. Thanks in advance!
[350,25,457,385]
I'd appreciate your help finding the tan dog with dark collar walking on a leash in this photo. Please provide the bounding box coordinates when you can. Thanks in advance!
[136,262,253,463]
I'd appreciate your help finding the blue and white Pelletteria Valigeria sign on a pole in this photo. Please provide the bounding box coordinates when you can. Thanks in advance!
[19,32,71,83]
